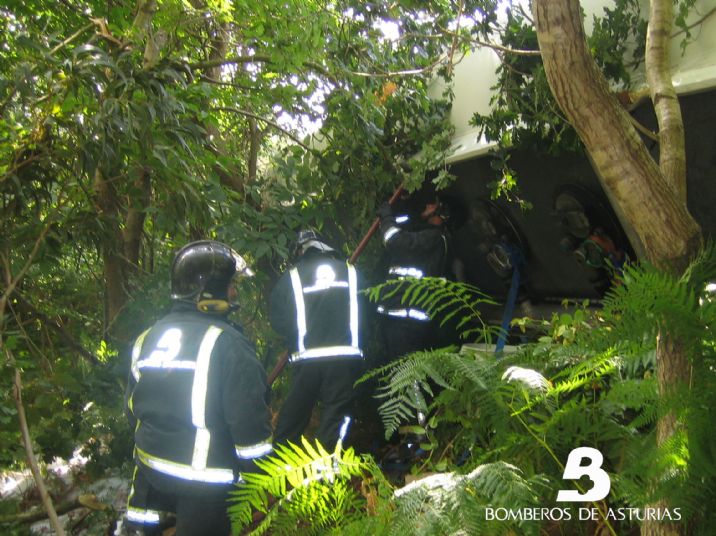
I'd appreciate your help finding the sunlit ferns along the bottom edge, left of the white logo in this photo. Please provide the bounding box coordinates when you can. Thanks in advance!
[229,439,545,535]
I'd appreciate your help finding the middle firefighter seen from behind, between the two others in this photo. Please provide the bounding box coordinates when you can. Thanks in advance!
[270,230,363,452]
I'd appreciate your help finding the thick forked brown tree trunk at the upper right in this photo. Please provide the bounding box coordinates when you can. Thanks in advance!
[533,0,702,535]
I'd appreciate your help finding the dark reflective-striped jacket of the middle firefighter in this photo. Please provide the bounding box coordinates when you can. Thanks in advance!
[270,249,363,363]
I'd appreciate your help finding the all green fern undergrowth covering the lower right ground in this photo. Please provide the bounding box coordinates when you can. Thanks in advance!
[232,247,716,535]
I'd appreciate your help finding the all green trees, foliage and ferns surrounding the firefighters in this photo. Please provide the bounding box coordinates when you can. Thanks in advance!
[0,0,716,535]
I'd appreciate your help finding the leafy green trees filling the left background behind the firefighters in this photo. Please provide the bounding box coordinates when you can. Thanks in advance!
[0,0,464,482]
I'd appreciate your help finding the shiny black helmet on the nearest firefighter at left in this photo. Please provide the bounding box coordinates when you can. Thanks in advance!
[171,240,253,310]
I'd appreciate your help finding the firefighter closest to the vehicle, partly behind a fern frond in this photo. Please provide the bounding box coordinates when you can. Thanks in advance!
[377,195,450,361]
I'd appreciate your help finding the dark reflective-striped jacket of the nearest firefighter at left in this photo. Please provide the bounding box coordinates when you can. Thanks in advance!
[127,304,272,492]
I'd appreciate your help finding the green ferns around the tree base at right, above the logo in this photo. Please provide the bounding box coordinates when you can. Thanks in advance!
[356,245,716,534]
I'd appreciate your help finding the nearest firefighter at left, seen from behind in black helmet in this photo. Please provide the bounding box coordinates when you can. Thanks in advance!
[126,240,272,536]
